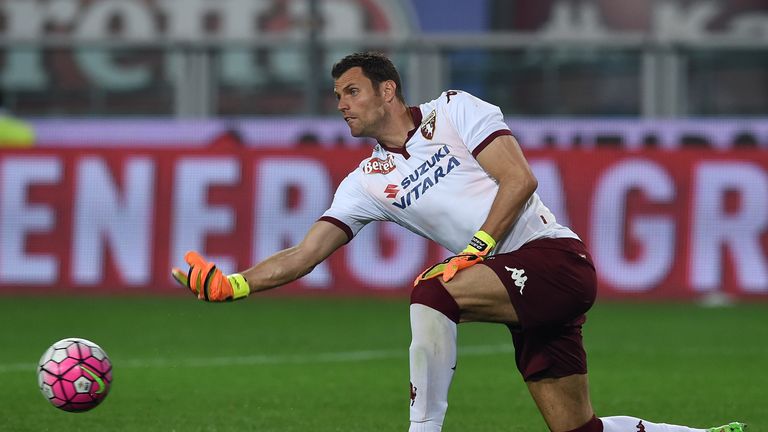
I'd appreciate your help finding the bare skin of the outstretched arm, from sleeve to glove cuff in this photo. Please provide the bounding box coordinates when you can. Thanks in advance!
[240,221,349,292]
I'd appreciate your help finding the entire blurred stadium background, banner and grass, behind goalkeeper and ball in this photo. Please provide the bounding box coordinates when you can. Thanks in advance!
[0,0,768,431]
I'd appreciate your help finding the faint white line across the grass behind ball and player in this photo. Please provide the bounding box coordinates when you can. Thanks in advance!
[0,344,513,373]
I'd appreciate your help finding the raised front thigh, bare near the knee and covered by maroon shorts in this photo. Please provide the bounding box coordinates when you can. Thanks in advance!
[443,238,597,328]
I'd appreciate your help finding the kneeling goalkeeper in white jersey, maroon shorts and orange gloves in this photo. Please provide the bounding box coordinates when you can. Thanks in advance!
[173,53,744,432]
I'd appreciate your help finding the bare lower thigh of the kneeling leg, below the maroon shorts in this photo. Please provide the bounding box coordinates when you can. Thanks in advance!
[526,374,594,432]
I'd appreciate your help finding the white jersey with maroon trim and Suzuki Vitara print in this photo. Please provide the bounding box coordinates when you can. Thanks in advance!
[321,90,578,254]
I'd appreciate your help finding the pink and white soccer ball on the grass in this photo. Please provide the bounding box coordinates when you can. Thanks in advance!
[37,338,112,412]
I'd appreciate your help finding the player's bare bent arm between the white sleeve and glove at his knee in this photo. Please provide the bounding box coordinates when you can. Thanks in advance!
[477,135,539,239]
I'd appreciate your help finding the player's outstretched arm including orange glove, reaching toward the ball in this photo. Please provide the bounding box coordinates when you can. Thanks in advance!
[171,221,348,301]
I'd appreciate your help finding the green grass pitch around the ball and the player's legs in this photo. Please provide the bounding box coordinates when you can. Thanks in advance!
[0,296,768,432]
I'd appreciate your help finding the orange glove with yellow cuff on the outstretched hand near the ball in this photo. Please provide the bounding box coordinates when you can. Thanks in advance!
[171,251,251,302]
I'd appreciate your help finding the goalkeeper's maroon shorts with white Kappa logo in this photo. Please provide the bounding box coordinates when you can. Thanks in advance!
[483,238,597,381]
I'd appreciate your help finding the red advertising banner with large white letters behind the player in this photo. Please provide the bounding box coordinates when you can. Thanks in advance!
[0,148,768,299]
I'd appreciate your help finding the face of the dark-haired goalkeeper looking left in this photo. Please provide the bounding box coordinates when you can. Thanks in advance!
[333,67,385,138]
